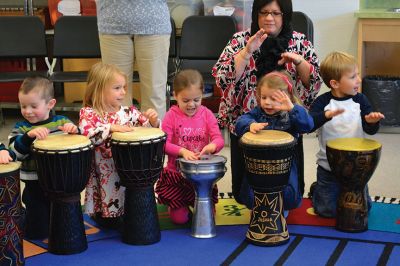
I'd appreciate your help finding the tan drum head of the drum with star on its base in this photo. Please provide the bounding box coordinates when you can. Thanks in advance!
[240,130,294,146]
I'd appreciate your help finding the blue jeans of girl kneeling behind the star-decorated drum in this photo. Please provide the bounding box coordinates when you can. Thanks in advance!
[240,160,302,210]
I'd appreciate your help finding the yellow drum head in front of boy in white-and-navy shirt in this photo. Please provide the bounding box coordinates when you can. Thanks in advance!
[326,138,382,151]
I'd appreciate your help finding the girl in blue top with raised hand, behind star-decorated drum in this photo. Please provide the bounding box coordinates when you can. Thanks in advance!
[235,71,314,210]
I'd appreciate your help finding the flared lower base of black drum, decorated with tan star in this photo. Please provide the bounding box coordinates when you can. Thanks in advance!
[246,191,289,246]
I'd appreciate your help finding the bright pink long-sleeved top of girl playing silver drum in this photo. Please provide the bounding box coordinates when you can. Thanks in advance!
[161,105,224,171]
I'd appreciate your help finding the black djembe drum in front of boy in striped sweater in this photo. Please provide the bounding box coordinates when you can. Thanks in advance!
[33,134,93,254]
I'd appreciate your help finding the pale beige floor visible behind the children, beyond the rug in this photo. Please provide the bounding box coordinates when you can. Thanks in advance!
[0,110,400,198]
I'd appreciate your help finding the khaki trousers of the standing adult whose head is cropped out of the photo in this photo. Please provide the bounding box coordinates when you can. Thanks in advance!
[99,34,170,119]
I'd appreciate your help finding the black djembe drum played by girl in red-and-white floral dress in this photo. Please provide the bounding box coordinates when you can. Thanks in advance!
[111,127,167,245]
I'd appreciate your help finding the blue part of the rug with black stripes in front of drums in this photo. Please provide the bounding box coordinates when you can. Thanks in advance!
[26,225,400,266]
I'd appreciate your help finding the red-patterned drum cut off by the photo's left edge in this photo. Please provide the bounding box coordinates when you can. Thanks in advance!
[0,162,25,266]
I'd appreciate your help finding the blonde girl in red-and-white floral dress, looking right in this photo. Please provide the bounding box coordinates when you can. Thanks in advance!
[79,62,160,228]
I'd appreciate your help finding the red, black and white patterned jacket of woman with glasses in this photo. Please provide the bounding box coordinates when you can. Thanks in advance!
[212,29,322,134]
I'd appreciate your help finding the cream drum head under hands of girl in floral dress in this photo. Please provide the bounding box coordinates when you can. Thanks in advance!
[111,127,165,142]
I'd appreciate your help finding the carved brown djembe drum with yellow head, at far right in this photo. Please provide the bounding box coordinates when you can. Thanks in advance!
[326,138,382,232]
